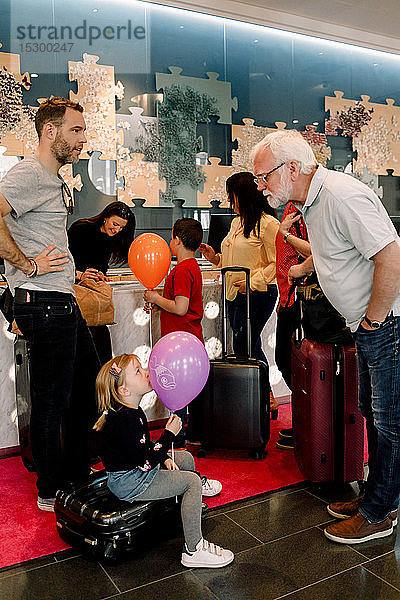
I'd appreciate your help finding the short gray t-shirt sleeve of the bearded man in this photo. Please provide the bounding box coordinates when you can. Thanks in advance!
[0,160,43,217]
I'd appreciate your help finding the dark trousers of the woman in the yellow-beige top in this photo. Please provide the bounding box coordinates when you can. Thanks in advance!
[227,284,278,394]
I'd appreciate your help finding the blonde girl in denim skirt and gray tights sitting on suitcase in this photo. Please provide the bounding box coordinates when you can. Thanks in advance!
[94,354,234,568]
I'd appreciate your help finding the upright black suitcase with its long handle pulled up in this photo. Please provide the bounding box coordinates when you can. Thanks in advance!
[195,267,270,459]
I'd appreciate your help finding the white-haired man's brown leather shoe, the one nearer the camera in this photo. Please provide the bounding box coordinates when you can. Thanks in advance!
[324,512,393,544]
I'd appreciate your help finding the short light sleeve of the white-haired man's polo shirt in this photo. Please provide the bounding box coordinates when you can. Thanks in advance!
[337,196,398,260]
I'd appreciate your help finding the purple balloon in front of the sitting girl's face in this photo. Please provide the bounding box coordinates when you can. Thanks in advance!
[149,331,210,411]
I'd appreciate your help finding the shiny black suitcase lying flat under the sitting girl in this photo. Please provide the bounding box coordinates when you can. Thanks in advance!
[54,470,180,561]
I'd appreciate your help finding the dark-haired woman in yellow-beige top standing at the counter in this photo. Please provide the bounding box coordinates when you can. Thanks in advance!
[199,172,279,414]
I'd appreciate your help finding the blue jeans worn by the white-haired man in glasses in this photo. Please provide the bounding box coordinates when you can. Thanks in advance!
[355,317,400,523]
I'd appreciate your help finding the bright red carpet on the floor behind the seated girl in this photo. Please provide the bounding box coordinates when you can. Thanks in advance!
[0,405,366,567]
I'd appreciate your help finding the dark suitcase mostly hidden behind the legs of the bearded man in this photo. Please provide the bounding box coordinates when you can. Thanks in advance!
[14,335,35,471]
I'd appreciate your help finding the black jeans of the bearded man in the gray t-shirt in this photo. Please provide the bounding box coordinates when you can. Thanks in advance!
[14,289,100,498]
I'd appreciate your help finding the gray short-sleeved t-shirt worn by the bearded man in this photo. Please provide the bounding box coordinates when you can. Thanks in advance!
[0,156,75,294]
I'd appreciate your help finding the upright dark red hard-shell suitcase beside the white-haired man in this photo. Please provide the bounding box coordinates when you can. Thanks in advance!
[292,336,364,483]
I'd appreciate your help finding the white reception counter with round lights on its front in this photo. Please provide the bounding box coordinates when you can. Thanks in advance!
[0,278,290,456]
